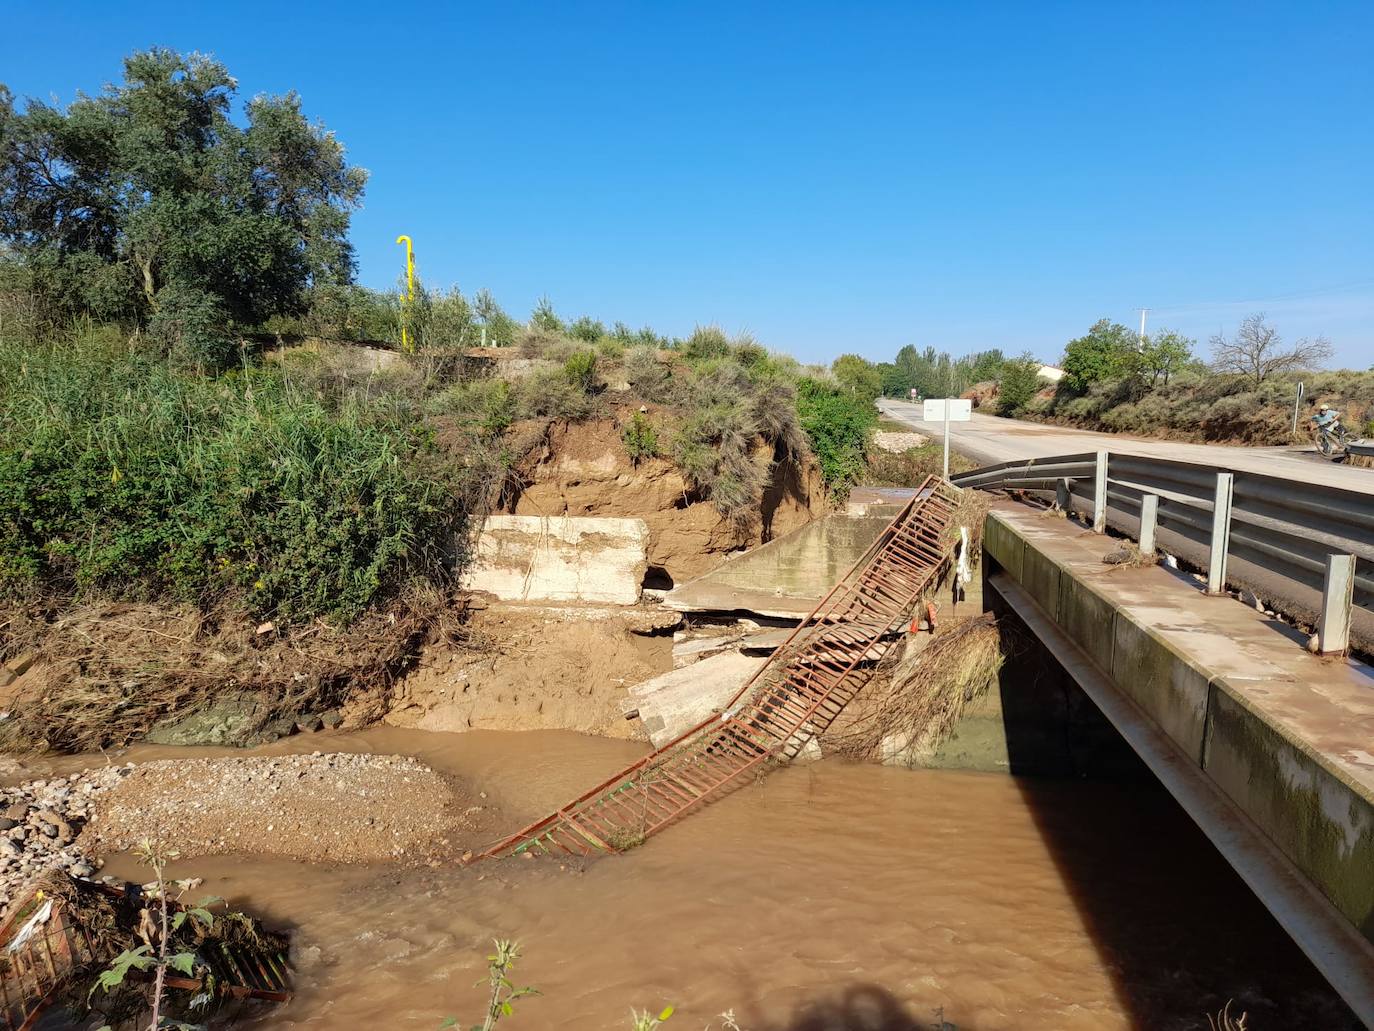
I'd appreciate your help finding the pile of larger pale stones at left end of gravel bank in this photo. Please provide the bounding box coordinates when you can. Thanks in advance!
[0,763,133,916]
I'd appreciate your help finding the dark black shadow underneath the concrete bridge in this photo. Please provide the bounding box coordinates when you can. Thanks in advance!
[999,610,1360,1031]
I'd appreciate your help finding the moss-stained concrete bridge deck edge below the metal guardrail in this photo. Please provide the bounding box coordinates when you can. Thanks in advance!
[984,500,1374,1026]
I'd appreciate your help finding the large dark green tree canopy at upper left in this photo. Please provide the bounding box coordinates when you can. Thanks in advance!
[0,48,367,336]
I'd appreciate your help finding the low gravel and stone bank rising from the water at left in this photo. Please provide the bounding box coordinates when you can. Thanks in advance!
[0,752,495,916]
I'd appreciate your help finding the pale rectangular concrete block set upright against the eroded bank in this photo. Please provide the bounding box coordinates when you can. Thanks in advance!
[466,516,649,605]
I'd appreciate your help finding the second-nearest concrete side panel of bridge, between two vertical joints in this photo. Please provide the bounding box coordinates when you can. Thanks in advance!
[1112,612,1209,766]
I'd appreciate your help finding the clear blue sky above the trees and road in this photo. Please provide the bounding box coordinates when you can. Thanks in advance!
[0,0,1374,367]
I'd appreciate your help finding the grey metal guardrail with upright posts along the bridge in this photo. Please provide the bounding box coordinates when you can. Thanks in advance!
[952,451,1374,654]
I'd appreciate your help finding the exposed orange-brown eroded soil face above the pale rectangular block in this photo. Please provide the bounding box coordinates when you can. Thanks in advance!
[500,410,827,587]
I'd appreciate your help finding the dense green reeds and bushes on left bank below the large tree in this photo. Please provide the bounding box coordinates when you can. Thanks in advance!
[0,334,483,623]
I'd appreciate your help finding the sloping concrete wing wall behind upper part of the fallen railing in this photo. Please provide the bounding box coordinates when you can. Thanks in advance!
[664,513,890,619]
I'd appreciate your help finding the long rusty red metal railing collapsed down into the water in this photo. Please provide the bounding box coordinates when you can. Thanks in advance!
[473,477,959,861]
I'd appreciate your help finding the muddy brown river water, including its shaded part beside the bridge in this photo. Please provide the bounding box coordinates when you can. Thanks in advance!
[18,729,1358,1031]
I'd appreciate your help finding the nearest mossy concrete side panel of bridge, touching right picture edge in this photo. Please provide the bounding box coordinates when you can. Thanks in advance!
[1202,678,1374,942]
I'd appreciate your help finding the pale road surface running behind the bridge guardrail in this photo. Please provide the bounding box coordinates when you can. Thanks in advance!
[878,399,1374,494]
